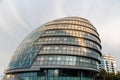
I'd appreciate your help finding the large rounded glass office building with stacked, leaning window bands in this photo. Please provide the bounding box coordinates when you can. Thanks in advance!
[5,17,101,80]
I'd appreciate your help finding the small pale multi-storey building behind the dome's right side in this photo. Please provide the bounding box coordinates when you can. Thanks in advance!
[100,55,116,73]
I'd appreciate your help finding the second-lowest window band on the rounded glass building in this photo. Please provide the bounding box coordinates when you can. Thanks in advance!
[38,45,100,60]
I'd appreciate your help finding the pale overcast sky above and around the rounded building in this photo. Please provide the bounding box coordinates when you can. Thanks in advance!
[0,0,120,74]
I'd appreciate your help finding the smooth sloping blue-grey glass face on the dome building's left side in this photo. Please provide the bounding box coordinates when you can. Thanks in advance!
[8,27,44,69]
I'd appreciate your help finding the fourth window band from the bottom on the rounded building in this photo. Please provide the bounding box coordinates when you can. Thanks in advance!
[41,29,101,43]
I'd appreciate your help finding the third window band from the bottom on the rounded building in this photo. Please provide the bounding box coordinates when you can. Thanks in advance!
[34,37,101,51]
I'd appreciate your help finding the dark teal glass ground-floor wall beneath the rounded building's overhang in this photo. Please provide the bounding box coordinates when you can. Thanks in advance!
[13,69,95,80]
